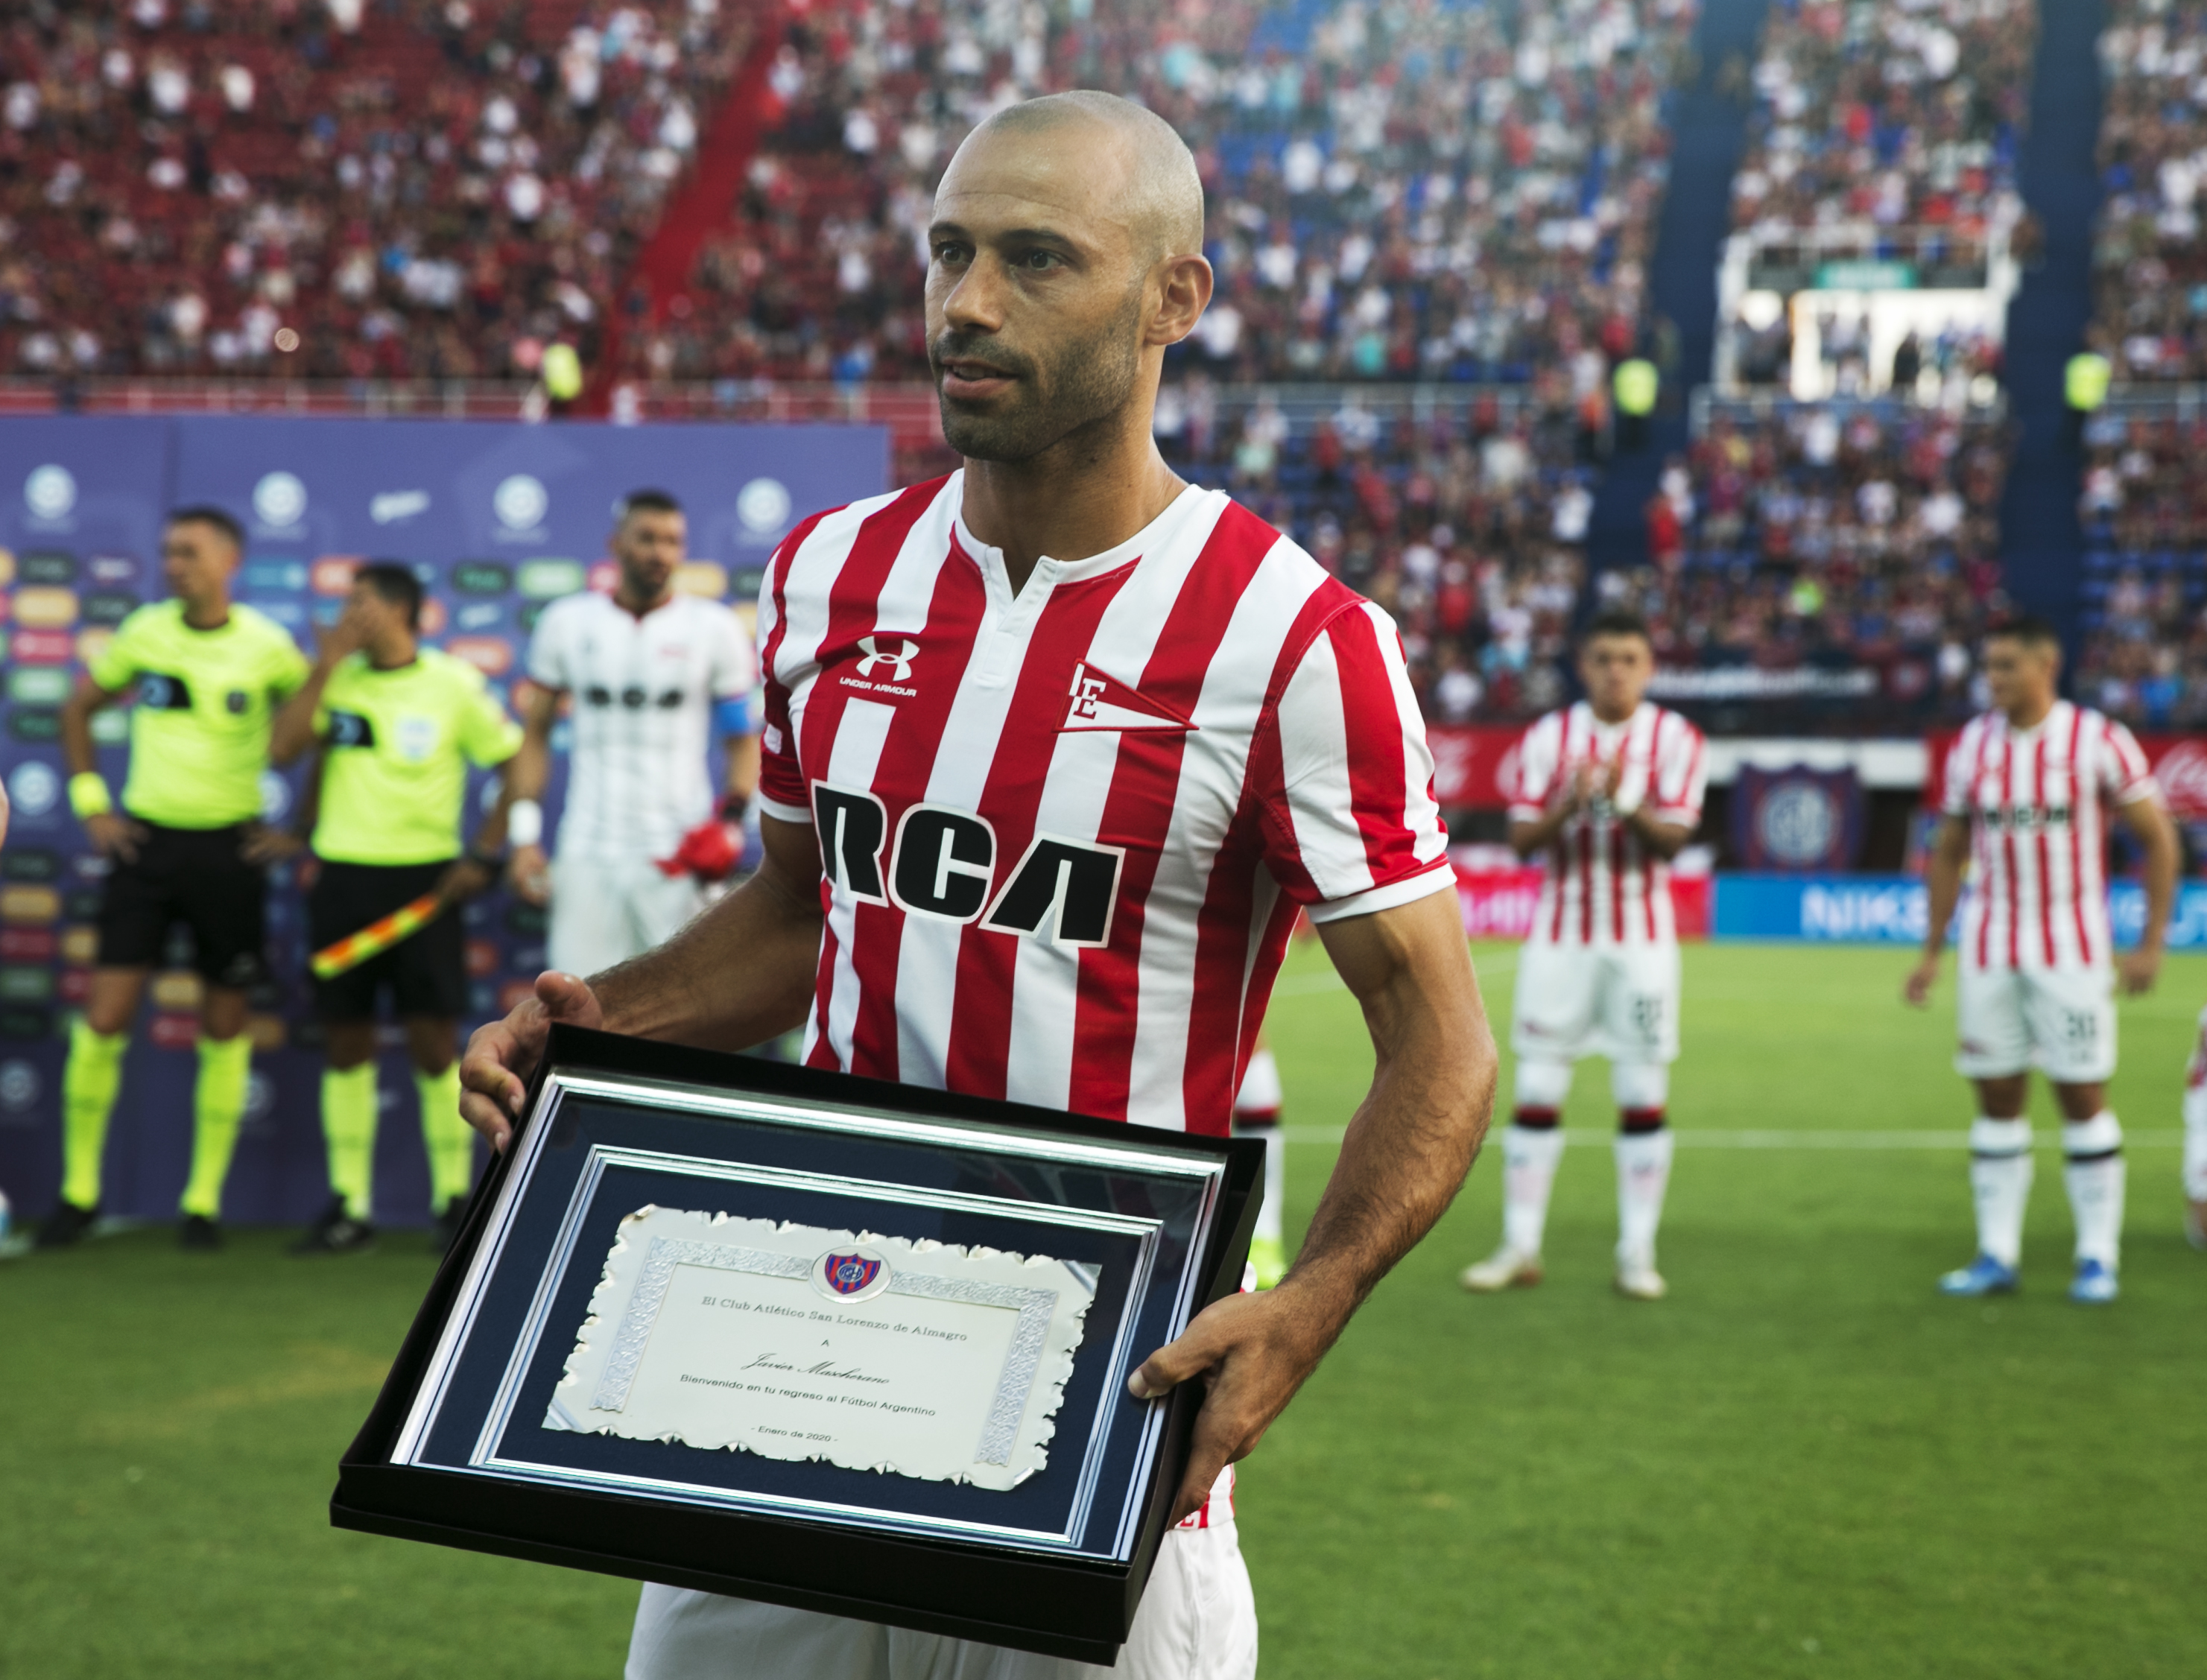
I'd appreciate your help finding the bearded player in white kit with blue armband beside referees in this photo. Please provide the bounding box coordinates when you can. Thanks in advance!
[510,490,759,974]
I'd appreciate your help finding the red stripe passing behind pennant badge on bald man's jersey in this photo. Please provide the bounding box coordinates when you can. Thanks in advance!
[1068,506,1279,1119]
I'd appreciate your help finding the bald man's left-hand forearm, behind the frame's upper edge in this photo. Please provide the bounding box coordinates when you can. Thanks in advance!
[589,870,821,1050]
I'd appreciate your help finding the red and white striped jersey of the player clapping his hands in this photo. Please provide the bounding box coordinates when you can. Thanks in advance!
[1510,700,1709,945]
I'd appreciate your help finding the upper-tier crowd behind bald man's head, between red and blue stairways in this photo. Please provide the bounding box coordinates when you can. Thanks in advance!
[631,0,1695,386]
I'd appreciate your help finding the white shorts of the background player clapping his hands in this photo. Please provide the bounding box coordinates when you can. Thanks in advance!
[1510,940,1677,1062]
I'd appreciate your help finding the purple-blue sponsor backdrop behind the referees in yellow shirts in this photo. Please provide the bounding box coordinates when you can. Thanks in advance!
[0,417,890,1223]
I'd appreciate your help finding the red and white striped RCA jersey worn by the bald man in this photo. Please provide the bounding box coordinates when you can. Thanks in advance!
[759,472,1452,1135]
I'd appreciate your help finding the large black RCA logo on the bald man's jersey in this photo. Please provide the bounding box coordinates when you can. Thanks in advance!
[812,782,1126,945]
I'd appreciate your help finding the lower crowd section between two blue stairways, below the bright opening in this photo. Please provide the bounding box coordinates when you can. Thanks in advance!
[1596,399,2008,731]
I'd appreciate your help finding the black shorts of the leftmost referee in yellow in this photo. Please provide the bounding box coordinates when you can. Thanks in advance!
[99,821,267,991]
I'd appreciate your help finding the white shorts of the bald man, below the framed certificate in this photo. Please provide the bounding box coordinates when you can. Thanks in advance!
[622,1521,1256,1680]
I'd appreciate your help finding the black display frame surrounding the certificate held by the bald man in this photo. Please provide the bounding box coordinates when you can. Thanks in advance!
[329,1027,1264,1664]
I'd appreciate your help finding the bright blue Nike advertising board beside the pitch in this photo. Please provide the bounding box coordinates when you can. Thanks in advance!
[1709,874,2207,949]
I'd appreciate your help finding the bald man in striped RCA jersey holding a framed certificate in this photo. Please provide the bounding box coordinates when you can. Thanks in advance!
[463,92,1494,1680]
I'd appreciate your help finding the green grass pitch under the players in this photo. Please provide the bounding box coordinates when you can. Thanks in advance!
[0,947,2207,1680]
